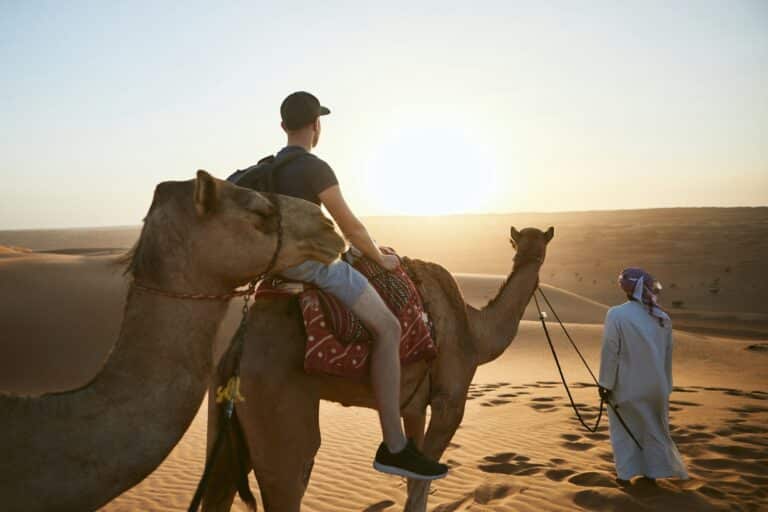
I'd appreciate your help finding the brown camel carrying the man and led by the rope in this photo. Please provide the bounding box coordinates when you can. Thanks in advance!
[204,227,554,512]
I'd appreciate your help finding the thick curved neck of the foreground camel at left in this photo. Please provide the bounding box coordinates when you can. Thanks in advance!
[0,288,227,510]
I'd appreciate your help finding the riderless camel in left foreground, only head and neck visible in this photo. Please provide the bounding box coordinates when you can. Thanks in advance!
[0,171,344,511]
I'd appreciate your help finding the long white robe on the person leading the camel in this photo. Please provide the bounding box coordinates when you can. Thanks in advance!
[600,301,688,480]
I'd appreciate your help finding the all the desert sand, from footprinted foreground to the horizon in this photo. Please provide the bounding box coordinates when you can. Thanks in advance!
[0,209,768,512]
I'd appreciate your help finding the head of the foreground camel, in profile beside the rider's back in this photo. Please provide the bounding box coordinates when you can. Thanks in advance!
[126,171,344,290]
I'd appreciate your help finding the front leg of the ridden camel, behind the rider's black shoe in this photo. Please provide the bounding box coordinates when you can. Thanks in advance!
[403,393,466,512]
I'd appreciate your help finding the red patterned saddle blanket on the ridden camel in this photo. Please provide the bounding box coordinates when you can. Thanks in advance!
[256,247,437,378]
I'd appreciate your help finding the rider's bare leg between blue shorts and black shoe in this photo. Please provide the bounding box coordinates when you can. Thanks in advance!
[352,284,406,453]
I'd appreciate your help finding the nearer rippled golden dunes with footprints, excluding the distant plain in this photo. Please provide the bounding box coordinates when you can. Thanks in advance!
[0,242,768,512]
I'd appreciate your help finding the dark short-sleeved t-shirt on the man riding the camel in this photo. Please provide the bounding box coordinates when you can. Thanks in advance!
[274,146,339,206]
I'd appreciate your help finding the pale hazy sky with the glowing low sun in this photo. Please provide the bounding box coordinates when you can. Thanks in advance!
[0,0,768,229]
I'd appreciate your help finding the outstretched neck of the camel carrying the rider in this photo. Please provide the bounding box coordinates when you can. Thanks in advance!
[467,261,541,364]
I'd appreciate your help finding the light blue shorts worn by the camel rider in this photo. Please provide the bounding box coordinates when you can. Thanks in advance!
[280,260,368,308]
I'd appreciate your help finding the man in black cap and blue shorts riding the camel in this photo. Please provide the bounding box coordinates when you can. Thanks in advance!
[230,92,448,480]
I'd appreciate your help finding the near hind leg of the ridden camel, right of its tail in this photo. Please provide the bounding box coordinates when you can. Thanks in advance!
[243,376,320,512]
